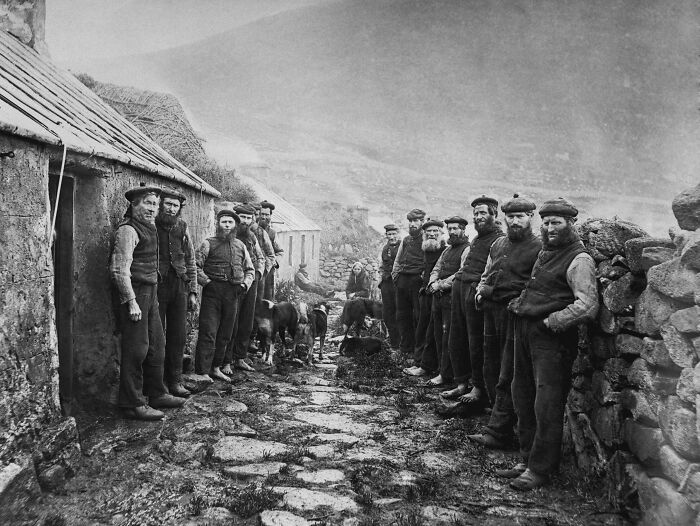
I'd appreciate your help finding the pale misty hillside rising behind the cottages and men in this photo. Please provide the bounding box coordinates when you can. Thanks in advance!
[74,0,700,233]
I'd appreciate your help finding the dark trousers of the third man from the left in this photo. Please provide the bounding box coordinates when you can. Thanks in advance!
[194,281,243,374]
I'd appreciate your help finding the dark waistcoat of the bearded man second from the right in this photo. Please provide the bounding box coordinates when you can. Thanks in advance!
[490,234,542,302]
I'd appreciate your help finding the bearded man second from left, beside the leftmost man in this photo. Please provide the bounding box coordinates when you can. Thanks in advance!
[156,189,197,397]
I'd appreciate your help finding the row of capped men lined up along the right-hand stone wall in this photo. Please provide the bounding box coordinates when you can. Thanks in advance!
[380,194,598,490]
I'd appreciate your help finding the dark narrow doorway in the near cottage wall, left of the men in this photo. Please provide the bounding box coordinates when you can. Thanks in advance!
[49,174,75,416]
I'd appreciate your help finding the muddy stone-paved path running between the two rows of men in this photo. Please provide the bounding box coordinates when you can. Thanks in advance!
[29,340,624,526]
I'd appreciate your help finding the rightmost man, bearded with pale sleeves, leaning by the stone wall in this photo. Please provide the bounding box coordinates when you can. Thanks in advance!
[508,197,598,491]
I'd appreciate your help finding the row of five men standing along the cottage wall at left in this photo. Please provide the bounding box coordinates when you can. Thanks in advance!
[110,186,283,420]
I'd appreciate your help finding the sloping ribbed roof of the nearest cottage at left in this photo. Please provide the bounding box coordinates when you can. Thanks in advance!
[0,31,220,197]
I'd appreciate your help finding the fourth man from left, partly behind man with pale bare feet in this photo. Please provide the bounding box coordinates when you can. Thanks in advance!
[221,205,269,375]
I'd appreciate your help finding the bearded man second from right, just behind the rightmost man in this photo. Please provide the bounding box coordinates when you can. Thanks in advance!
[468,194,542,449]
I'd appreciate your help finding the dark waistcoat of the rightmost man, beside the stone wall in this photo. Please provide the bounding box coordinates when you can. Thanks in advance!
[515,241,586,318]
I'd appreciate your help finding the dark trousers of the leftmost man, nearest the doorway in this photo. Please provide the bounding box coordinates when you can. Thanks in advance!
[119,282,167,408]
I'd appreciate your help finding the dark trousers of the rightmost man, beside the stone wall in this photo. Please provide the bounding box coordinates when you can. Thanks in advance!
[512,317,578,475]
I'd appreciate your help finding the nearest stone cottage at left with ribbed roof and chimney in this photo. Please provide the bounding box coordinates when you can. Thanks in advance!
[0,0,219,510]
